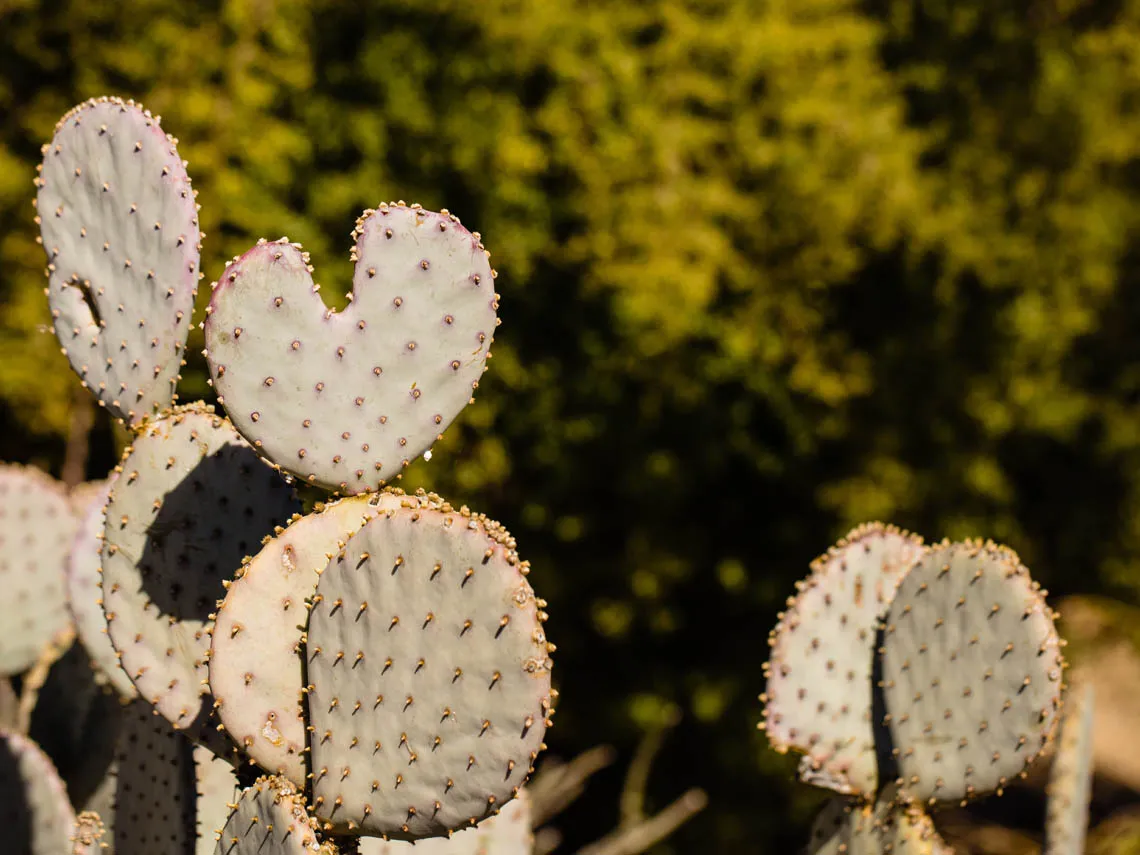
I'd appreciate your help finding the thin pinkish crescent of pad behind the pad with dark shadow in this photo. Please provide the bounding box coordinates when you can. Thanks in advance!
[67,481,137,700]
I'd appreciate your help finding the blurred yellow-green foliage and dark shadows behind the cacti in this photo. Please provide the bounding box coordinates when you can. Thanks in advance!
[0,0,1140,853]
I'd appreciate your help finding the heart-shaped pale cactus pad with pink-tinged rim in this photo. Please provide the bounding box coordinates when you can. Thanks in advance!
[203,204,498,494]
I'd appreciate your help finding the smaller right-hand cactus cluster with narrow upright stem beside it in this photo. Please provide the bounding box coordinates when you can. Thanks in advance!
[759,523,1091,855]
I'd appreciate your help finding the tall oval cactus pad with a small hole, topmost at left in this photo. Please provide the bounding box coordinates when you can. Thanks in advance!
[35,98,201,424]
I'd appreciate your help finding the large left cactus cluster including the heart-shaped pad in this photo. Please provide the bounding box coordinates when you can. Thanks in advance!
[0,98,556,855]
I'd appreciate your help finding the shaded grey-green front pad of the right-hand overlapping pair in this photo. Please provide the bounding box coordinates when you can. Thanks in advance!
[882,542,1062,803]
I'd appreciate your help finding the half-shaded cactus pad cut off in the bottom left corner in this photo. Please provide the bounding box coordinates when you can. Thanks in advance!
[0,732,75,855]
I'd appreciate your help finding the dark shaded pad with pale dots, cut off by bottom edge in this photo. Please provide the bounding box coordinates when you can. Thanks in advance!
[111,699,197,855]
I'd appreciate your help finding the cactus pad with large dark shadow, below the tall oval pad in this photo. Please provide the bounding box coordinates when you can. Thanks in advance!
[100,405,300,732]
